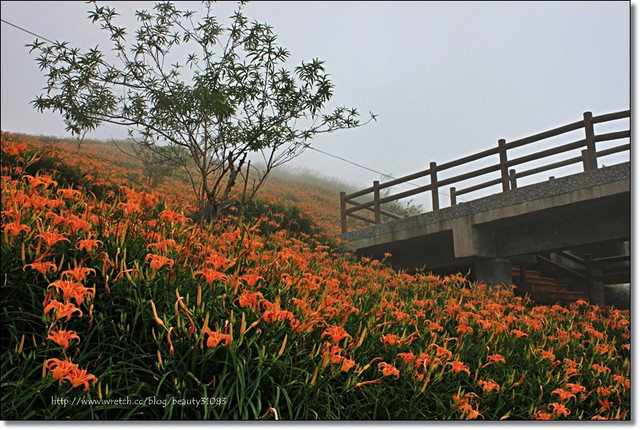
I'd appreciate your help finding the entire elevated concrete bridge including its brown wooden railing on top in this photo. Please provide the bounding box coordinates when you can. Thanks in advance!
[340,110,631,302]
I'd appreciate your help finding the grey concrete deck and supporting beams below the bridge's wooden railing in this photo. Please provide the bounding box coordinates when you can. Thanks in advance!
[340,162,631,284]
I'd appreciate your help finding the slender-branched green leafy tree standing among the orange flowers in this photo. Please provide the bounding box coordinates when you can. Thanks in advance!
[28,2,375,219]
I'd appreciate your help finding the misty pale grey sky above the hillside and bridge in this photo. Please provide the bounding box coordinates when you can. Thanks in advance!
[1,1,632,191]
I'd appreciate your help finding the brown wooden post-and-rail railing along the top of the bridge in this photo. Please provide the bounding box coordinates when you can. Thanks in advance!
[340,110,631,233]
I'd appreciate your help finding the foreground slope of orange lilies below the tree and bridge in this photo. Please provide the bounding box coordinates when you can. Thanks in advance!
[0,134,631,420]
